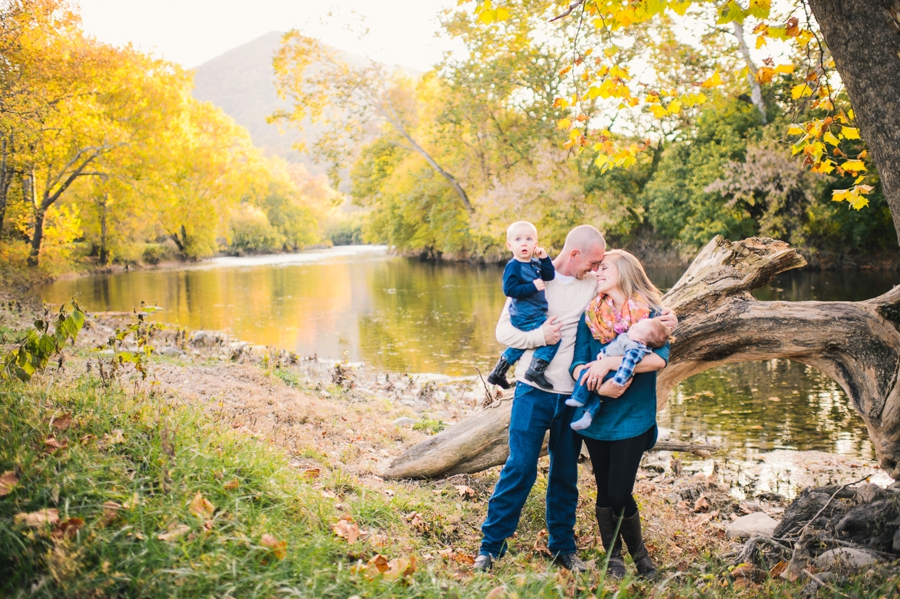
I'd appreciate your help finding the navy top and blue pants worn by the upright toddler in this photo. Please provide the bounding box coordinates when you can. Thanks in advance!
[503,256,559,364]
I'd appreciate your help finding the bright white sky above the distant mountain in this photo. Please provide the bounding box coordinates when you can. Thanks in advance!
[76,0,460,71]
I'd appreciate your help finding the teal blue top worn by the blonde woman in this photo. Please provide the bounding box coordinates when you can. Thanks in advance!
[569,314,669,449]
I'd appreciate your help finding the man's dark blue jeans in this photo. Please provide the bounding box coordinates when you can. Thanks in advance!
[480,383,581,557]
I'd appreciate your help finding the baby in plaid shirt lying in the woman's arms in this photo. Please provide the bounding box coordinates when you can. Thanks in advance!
[566,318,669,431]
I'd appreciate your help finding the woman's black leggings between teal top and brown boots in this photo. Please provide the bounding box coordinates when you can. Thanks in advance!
[582,427,655,518]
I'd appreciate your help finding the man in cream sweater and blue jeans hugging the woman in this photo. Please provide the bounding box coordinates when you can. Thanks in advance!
[474,225,677,572]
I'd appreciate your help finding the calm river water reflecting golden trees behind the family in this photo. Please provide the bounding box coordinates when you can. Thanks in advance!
[42,246,900,459]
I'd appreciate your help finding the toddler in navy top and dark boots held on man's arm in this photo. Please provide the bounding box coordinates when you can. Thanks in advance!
[488,220,559,389]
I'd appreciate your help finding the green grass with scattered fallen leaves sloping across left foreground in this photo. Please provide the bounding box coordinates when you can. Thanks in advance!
[0,377,898,599]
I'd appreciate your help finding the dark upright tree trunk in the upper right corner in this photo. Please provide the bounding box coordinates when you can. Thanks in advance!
[808,0,900,241]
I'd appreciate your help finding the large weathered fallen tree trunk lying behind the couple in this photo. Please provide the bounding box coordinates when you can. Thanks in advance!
[384,237,900,478]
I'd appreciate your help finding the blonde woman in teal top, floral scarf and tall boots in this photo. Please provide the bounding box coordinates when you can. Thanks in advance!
[571,250,669,579]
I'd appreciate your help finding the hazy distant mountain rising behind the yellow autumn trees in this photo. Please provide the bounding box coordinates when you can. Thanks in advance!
[194,31,420,174]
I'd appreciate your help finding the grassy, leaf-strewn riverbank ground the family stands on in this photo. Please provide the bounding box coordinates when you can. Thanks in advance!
[0,304,900,599]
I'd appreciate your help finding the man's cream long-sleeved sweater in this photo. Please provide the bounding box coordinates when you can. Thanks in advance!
[496,272,597,394]
